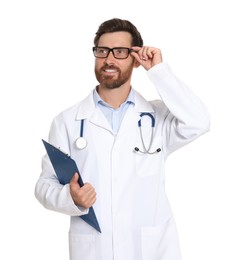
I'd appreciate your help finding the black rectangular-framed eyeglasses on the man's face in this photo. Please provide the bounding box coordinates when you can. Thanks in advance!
[92,47,133,59]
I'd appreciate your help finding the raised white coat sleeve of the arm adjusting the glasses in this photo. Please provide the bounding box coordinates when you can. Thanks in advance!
[148,62,210,156]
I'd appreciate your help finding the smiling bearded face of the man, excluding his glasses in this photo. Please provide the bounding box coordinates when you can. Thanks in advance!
[95,32,135,89]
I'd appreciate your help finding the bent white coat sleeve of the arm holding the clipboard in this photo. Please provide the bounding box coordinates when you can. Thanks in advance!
[35,119,88,216]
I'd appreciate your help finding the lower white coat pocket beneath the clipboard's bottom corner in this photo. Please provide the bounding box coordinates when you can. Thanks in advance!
[69,233,95,260]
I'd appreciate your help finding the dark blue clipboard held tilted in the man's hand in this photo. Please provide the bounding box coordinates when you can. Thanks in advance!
[42,140,101,233]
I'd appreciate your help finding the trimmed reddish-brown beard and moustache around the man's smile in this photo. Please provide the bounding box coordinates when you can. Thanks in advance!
[95,65,133,89]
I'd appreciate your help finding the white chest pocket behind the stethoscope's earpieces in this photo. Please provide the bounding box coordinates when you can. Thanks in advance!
[134,136,164,177]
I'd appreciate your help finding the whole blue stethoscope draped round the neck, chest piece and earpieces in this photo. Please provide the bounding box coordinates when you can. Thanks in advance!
[75,112,161,154]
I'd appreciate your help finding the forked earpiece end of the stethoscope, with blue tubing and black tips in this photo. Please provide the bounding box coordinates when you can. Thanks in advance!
[134,112,161,154]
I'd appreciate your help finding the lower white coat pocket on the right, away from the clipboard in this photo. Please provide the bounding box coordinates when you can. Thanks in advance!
[141,218,181,260]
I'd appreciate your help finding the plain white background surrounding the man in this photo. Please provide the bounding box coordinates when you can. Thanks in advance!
[0,0,244,260]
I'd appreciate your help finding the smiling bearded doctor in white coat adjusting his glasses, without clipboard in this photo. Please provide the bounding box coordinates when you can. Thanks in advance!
[35,19,209,260]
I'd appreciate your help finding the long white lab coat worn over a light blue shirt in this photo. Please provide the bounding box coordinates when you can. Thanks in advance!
[35,62,209,260]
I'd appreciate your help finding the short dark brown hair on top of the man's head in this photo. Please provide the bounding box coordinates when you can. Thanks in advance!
[94,18,143,47]
